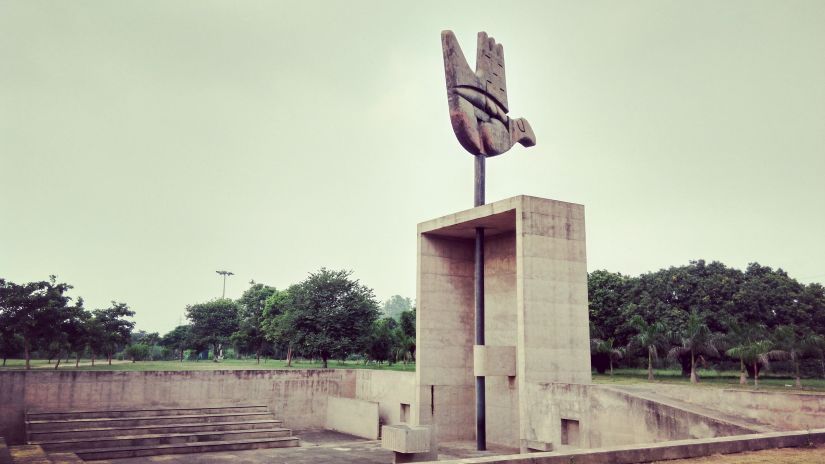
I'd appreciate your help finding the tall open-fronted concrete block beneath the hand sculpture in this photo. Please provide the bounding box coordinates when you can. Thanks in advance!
[414,196,591,448]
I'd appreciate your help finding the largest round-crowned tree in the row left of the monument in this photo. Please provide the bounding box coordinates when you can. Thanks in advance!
[284,268,378,368]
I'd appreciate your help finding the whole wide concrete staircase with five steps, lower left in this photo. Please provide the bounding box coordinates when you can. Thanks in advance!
[21,405,299,458]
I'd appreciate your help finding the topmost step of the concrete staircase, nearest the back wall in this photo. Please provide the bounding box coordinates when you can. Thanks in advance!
[26,404,269,421]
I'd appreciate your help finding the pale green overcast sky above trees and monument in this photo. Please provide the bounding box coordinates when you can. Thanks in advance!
[0,0,825,332]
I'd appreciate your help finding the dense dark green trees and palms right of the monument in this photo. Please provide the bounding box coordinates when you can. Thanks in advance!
[588,260,825,386]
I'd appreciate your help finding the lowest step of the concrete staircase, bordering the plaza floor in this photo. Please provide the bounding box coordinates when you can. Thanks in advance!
[75,437,300,461]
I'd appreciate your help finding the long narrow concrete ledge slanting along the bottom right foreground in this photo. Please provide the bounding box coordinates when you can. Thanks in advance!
[428,429,825,464]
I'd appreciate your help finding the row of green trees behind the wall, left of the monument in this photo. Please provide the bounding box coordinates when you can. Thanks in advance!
[0,269,415,369]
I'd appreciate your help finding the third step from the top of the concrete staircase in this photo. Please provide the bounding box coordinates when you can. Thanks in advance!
[27,419,283,440]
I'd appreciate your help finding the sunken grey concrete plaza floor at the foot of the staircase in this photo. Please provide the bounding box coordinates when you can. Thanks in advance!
[90,430,513,464]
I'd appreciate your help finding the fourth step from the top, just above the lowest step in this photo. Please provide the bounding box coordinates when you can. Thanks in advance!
[31,428,292,452]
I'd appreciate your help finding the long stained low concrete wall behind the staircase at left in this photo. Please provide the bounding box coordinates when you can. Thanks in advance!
[0,369,356,444]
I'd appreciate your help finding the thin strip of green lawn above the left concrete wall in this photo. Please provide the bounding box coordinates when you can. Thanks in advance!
[0,359,415,372]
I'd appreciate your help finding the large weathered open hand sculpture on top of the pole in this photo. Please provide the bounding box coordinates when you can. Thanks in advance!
[441,31,536,156]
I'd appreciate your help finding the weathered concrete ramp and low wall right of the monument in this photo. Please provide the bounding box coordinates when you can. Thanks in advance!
[620,384,825,430]
